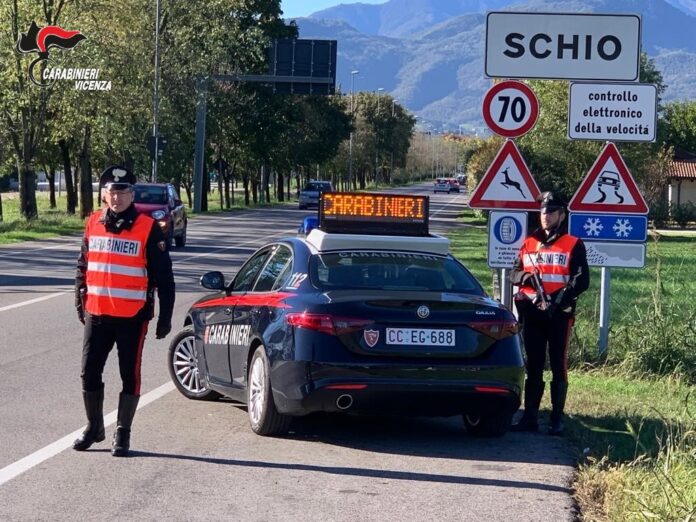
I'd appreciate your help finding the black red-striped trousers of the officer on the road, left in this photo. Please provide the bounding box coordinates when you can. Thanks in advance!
[81,314,149,396]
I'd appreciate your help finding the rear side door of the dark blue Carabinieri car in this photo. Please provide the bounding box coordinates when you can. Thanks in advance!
[230,244,292,386]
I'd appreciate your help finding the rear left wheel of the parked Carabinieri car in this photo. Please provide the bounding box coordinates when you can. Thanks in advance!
[247,345,292,435]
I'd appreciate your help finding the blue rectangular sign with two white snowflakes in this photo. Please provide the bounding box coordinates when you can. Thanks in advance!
[568,212,648,243]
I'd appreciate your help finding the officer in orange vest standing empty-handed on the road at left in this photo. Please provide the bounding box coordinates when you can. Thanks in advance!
[73,166,174,457]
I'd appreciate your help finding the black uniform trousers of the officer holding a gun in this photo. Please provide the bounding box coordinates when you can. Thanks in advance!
[520,301,575,383]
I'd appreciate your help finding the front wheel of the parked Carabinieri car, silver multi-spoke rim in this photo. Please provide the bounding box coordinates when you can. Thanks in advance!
[167,327,220,401]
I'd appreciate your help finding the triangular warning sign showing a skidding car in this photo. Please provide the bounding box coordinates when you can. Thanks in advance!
[568,143,648,214]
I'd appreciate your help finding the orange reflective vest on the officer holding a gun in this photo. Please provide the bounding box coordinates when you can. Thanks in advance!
[520,234,578,299]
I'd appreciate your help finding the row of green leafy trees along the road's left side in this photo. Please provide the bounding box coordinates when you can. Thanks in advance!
[0,0,415,220]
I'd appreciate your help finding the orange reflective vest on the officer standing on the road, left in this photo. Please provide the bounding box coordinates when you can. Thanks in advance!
[85,211,153,317]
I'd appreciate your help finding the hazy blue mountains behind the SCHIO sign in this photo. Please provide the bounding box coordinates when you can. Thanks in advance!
[297,0,696,131]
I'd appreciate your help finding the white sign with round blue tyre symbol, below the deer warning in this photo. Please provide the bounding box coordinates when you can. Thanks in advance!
[488,210,527,268]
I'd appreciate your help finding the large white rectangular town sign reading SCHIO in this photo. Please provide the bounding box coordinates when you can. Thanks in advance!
[485,12,641,82]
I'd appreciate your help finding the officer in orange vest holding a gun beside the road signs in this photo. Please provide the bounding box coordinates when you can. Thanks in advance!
[510,192,590,435]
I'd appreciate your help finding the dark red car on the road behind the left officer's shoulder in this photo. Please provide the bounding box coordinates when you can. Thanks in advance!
[134,183,188,247]
